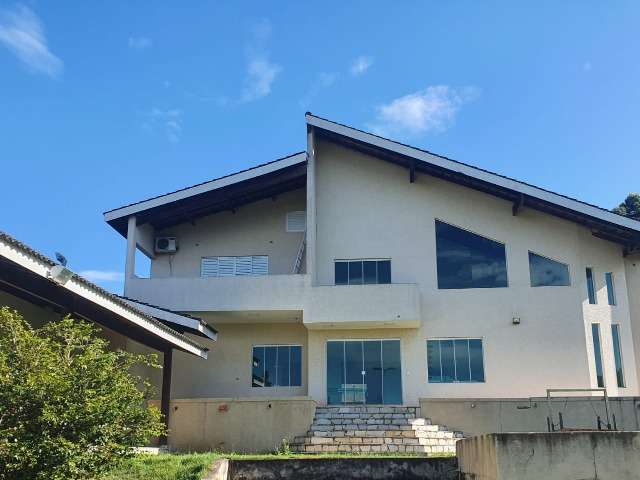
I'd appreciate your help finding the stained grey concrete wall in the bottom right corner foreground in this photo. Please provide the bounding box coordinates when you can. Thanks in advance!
[457,432,640,480]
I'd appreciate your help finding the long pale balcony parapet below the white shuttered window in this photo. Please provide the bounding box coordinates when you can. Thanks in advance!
[125,275,309,312]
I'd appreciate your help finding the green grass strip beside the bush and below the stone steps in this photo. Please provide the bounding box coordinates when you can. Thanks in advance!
[103,452,450,480]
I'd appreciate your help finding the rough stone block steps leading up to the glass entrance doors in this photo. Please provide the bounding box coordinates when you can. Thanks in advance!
[291,406,463,454]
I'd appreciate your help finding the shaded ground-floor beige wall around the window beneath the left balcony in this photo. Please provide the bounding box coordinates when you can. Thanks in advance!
[171,319,307,399]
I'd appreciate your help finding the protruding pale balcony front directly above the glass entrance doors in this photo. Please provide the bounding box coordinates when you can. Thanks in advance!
[303,283,420,329]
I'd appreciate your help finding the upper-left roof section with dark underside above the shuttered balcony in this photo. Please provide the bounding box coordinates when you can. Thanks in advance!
[104,152,307,236]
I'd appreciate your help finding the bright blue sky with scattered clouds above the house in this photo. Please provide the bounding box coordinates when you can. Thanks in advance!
[0,0,640,292]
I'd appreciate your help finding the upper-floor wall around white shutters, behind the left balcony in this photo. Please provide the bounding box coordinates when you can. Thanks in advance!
[151,189,306,278]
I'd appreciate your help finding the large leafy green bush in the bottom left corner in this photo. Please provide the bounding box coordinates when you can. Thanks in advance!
[0,307,165,480]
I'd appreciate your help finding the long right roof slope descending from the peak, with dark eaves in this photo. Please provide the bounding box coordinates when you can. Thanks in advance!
[306,112,640,247]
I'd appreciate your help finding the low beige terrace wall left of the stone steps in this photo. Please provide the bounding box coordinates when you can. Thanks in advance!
[153,397,316,452]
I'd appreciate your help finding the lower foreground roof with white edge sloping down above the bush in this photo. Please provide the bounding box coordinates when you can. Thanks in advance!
[0,231,208,358]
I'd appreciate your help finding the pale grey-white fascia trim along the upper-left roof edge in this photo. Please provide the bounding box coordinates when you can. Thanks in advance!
[104,152,307,222]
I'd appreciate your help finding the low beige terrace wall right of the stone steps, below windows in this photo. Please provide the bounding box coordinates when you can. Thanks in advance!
[420,397,640,436]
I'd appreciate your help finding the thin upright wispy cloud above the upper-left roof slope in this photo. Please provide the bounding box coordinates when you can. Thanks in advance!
[242,19,282,102]
